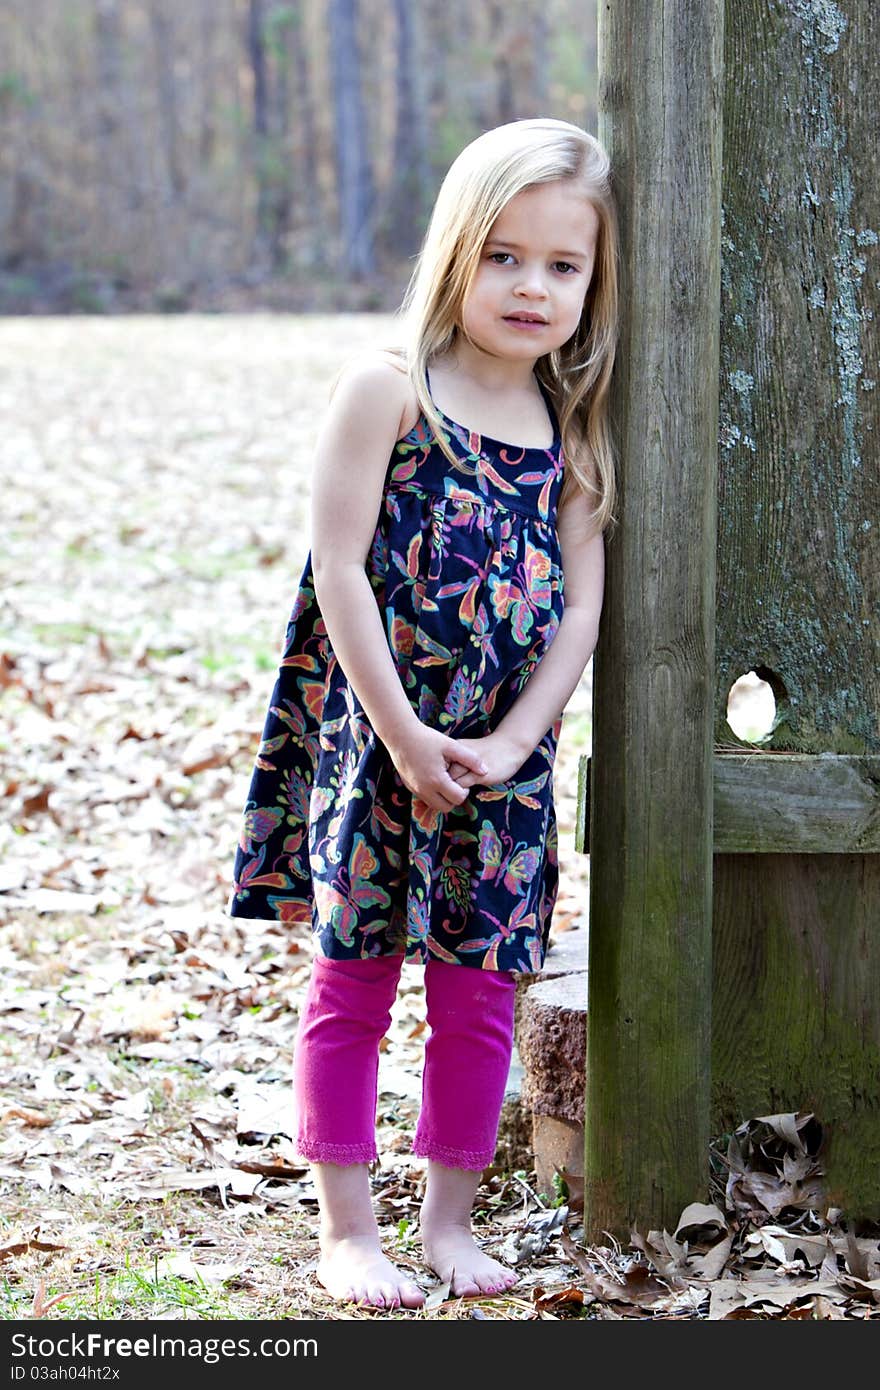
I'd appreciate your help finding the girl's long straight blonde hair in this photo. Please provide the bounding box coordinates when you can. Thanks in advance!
[389,117,619,534]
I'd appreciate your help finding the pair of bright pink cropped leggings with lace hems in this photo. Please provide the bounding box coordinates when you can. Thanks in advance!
[293,955,516,1170]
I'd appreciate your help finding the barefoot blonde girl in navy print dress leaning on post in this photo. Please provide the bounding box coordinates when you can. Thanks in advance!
[229,120,617,1307]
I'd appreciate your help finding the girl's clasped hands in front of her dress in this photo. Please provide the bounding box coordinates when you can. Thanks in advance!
[388,720,525,810]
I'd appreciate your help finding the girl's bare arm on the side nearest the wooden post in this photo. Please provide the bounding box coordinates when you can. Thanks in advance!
[450,492,605,787]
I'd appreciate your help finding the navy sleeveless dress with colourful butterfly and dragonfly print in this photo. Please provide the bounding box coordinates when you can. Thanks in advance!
[228,369,564,972]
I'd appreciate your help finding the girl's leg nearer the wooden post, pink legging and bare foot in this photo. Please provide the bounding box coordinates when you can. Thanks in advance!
[413,960,516,1294]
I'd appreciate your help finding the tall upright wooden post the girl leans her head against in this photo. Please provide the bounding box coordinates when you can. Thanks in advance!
[584,0,724,1240]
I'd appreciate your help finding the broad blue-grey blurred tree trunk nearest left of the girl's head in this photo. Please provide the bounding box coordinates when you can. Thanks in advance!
[329,0,375,278]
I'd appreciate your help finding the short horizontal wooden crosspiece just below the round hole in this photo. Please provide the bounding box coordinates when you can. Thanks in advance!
[715,753,880,853]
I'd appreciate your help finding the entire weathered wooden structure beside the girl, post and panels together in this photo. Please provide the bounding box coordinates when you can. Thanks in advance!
[585,0,880,1238]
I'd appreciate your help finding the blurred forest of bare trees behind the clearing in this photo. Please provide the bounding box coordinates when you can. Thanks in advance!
[0,0,596,314]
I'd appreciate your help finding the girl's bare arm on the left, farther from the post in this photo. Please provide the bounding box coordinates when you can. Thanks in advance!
[311,354,485,810]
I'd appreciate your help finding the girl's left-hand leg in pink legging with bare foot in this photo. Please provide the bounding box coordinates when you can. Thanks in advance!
[293,955,424,1308]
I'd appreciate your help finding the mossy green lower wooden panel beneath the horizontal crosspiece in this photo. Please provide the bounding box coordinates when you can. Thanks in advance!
[712,855,880,1220]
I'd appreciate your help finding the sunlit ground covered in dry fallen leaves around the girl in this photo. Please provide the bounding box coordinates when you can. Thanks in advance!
[0,316,880,1319]
